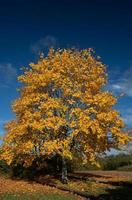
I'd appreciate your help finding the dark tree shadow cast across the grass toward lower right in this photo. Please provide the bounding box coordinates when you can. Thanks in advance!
[9,173,132,200]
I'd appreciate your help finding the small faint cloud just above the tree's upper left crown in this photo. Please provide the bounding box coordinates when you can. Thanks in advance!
[31,35,58,54]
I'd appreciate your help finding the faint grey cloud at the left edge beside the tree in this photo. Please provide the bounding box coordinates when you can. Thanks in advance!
[0,63,17,88]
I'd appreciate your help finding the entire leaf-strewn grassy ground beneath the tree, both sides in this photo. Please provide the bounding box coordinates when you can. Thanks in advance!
[0,171,132,200]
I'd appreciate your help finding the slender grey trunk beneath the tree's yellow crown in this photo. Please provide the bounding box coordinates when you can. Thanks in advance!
[61,156,68,184]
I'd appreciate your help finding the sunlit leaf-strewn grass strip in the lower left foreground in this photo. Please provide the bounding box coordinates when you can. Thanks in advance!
[0,174,83,200]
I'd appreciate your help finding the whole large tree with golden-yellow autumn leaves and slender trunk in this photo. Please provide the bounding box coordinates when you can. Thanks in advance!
[1,48,129,183]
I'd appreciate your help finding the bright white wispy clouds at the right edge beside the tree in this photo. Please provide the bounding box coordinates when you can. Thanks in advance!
[107,67,132,128]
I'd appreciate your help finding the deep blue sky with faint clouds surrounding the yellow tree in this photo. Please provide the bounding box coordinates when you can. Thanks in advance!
[0,0,132,133]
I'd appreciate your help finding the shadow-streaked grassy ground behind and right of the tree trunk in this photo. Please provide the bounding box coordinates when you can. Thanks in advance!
[36,171,132,200]
